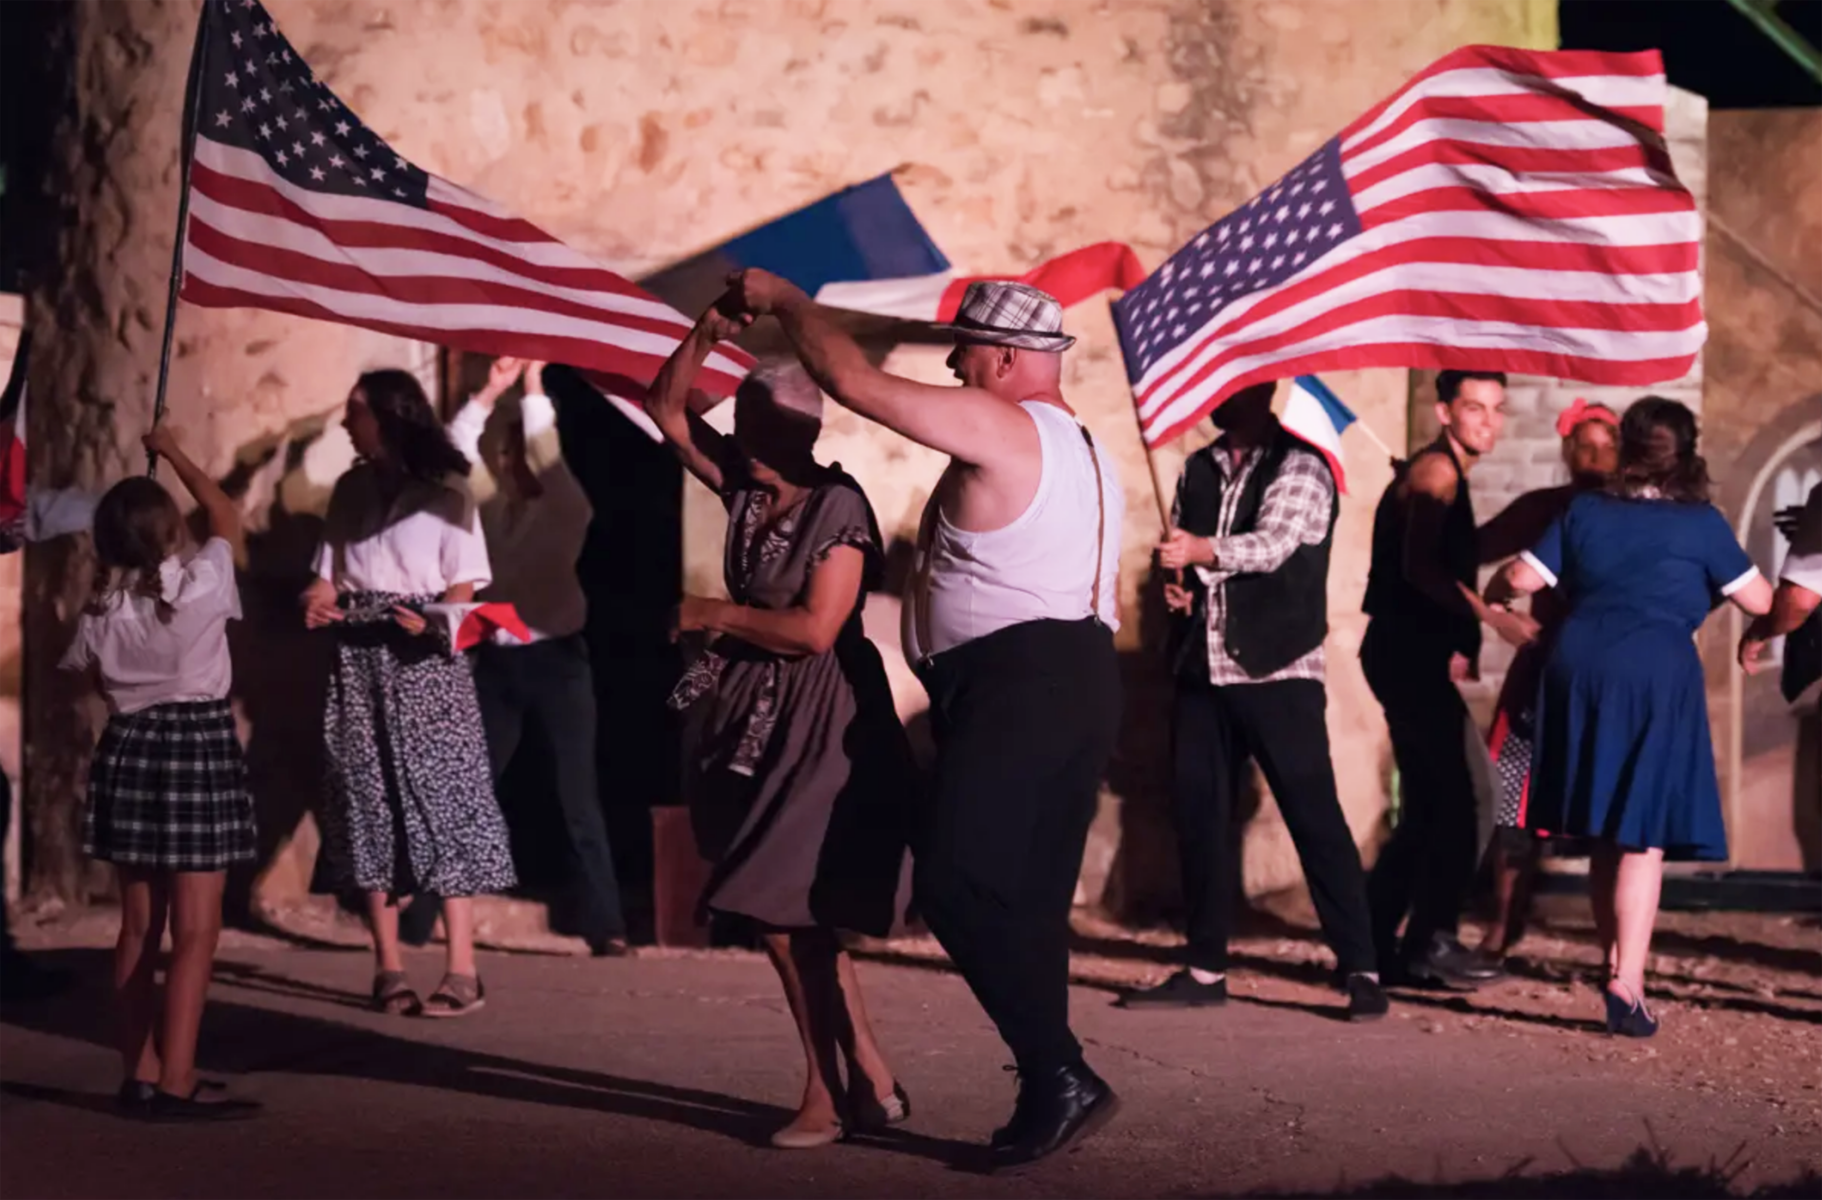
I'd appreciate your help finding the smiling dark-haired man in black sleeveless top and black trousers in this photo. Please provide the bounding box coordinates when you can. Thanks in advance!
[1361,371,1536,985]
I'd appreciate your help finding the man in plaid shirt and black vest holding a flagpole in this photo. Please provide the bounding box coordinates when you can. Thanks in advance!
[1121,384,1387,1020]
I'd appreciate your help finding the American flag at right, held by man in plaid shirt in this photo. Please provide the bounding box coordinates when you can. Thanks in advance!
[1113,46,1707,446]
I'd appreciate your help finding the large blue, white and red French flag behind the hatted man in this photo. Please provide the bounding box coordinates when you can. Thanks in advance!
[640,173,1144,331]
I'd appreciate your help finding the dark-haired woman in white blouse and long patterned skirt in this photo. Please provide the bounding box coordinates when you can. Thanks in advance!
[302,370,514,1016]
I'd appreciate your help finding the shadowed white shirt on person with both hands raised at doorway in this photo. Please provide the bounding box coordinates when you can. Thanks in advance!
[448,393,594,641]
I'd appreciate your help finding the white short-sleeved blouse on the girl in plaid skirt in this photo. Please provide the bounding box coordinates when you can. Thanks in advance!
[62,537,241,712]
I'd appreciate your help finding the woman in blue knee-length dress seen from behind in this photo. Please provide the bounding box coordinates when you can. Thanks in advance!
[1489,395,1771,1038]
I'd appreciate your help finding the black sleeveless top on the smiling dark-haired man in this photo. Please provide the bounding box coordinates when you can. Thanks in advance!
[1361,441,1481,657]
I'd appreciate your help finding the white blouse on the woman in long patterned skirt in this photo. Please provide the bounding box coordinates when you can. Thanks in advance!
[317,464,492,595]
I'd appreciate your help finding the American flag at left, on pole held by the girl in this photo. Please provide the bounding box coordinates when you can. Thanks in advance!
[182,0,752,404]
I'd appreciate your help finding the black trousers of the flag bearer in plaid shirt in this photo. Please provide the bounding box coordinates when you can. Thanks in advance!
[1172,679,1376,972]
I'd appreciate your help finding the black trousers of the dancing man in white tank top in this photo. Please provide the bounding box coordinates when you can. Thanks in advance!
[915,621,1121,1074]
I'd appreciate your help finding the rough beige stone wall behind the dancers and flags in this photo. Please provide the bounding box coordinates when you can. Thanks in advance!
[14,0,1554,912]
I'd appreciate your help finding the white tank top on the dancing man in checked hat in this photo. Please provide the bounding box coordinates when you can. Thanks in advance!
[902,401,1126,663]
